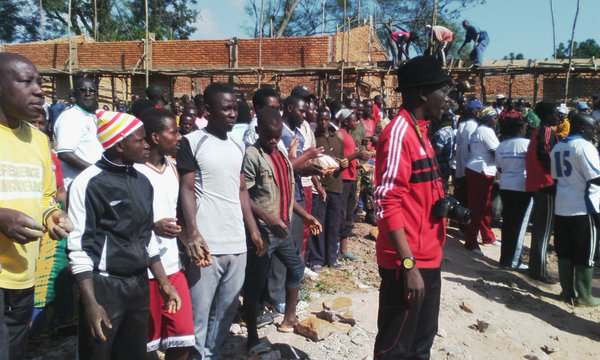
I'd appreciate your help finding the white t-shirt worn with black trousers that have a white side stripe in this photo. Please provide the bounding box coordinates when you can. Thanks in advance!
[496,137,529,191]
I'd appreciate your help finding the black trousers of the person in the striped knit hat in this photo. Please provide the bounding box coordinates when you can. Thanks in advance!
[77,271,150,360]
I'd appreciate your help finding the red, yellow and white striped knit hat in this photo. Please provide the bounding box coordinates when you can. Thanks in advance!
[96,110,143,150]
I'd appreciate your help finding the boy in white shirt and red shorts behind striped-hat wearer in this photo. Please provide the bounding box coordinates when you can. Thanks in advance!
[134,108,195,360]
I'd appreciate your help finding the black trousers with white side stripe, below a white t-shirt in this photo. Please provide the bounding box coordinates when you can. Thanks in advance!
[500,190,532,267]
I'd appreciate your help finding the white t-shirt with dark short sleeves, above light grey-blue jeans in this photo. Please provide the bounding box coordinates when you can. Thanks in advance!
[177,129,246,255]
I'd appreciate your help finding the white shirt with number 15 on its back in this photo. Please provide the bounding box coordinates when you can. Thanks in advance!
[550,135,600,216]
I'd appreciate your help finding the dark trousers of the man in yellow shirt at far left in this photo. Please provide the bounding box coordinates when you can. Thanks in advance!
[0,287,33,360]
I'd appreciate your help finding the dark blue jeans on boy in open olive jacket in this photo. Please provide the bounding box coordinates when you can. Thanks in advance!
[244,223,304,302]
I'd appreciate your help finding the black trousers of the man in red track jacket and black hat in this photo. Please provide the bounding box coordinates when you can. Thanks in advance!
[374,267,441,360]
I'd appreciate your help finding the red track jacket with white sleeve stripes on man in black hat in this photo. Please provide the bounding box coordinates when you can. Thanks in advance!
[374,109,446,269]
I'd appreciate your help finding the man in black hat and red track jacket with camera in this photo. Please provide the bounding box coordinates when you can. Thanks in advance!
[374,56,452,359]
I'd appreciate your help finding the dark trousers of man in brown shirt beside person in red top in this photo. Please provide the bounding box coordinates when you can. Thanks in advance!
[308,192,342,266]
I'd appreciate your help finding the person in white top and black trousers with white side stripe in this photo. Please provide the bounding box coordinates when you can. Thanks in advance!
[496,116,533,269]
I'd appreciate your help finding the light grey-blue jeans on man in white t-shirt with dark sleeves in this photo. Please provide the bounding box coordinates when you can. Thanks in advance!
[185,253,246,360]
